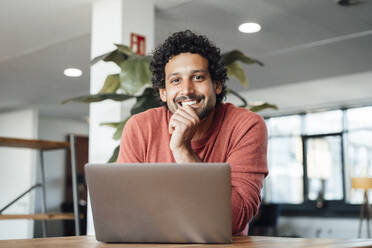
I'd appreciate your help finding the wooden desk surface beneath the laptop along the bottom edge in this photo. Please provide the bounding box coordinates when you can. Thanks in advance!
[0,236,372,248]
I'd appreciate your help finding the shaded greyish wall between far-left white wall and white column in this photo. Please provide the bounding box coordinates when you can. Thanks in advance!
[35,116,89,237]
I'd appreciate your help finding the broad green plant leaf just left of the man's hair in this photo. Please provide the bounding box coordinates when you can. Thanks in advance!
[120,55,151,95]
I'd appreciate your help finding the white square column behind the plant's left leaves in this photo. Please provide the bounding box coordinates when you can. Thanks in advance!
[88,0,155,235]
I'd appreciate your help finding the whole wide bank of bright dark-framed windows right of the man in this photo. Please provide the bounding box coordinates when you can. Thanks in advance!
[264,106,372,209]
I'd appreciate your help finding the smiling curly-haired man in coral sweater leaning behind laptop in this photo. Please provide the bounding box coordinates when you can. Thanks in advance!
[118,30,267,234]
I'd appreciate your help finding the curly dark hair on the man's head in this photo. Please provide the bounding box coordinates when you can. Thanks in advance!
[150,30,227,104]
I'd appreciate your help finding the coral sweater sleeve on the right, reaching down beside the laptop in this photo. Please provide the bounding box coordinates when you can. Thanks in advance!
[227,114,268,234]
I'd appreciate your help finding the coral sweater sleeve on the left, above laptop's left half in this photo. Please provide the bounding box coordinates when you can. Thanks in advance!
[117,116,144,163]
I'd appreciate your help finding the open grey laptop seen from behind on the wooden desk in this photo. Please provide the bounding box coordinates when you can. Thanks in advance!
[85,163,232,243]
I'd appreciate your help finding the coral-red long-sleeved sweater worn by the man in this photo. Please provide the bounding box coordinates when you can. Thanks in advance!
[118,103,268,234]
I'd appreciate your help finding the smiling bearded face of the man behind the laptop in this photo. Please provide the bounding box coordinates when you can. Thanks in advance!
[159,53,222,120]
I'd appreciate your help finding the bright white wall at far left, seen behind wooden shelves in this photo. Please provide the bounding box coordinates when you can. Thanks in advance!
[0,109,38,239]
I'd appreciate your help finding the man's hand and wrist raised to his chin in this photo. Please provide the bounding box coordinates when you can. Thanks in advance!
[169,105,201,163]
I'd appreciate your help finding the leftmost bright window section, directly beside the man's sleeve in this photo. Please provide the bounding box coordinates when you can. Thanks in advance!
[264,116,303,203]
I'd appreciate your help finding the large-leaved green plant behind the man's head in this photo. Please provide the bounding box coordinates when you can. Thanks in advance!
[62,44,277,162]
